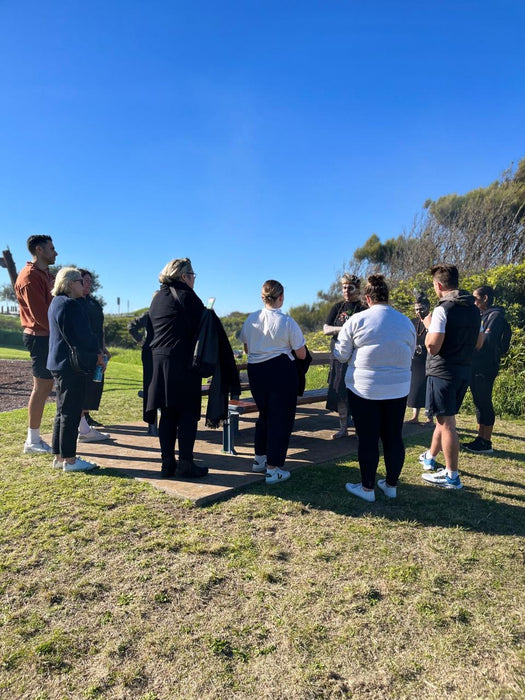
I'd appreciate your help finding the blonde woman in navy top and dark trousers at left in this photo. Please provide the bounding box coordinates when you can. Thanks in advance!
[47,267,105,472]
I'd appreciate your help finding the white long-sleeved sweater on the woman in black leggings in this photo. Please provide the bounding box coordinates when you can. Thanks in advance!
[334,304,416,401]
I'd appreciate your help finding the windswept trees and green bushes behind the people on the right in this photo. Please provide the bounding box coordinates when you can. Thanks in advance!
[290,158,525,331]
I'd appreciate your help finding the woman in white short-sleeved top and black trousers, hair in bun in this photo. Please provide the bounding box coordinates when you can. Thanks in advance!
[240,280,306,484]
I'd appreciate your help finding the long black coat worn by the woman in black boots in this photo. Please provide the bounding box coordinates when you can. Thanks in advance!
[146,281,204,422]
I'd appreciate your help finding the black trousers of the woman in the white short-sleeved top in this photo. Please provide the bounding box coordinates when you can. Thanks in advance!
[248,355,298,467]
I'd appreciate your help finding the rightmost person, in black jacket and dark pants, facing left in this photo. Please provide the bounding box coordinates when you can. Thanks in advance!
[462,285,505,454]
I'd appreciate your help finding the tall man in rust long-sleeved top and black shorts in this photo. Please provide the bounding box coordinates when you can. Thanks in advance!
[15,235,57,454]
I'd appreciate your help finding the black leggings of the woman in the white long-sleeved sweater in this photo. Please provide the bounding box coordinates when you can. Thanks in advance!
[348,390,407,489]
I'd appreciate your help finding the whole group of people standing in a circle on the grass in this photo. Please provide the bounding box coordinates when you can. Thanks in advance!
[16,236,504,494]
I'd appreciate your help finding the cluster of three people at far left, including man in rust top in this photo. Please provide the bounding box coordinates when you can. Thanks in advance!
[15,235,109,471]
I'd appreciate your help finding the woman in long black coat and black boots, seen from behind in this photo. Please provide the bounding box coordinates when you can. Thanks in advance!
[146,258,208,478]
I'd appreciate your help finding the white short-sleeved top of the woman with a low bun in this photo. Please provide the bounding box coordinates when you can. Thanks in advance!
[239,308,305,364]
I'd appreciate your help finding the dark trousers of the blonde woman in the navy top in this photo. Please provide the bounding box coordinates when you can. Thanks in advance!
[51,369,87,458]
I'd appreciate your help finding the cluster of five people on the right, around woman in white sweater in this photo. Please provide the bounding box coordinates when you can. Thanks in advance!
[324,265,506,502]
